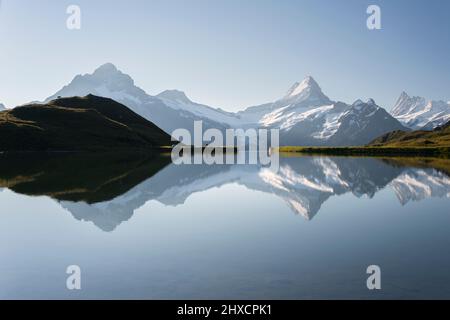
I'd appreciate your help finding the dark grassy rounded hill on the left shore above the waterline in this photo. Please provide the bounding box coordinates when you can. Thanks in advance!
[0,95,172,151]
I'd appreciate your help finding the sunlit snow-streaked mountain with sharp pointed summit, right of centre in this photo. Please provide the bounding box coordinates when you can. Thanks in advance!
[239,77,407,146]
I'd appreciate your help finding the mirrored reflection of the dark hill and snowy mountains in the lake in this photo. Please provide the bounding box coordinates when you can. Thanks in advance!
[0,154,450,231]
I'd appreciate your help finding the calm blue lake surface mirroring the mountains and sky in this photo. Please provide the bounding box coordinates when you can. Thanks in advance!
[0,155,450,299]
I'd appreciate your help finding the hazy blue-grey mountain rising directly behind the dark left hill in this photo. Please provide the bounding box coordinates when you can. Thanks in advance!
[46,63,239,134]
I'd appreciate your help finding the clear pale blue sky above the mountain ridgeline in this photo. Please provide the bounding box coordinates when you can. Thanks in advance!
[0,0,450,110]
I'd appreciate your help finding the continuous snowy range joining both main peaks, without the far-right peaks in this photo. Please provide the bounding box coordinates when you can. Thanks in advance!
[41,63,414,146]
